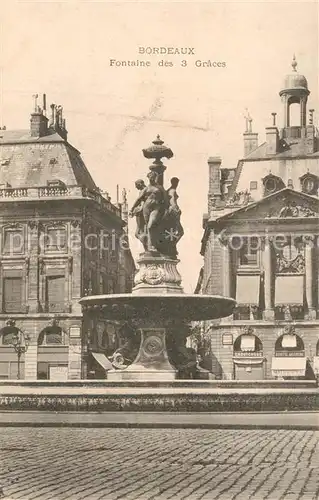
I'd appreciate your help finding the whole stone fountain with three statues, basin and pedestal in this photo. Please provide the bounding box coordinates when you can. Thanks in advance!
[80,136,235,382]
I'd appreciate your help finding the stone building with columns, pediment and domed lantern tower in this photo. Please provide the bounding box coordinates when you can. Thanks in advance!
[196,59,319,380]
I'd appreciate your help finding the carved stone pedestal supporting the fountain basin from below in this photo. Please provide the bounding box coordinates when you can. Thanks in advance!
[107,328,176,382]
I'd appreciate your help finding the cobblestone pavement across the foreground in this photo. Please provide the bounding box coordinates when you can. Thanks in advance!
[0,427,319,500]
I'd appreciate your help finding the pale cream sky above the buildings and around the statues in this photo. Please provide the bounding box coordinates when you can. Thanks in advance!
[0,0,319,292]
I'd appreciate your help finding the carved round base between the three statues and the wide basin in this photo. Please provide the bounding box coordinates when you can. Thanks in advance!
[132,253,183,295]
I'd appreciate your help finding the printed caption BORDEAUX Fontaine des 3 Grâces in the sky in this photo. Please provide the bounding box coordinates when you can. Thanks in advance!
[109,46,226,68]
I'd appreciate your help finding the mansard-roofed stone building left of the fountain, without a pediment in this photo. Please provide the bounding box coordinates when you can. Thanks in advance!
[0,96,135,380]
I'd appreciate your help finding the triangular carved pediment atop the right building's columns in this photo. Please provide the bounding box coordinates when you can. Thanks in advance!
[220,188,319,220]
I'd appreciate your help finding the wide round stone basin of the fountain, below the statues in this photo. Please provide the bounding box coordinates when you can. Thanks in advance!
[80,293,236,322]
